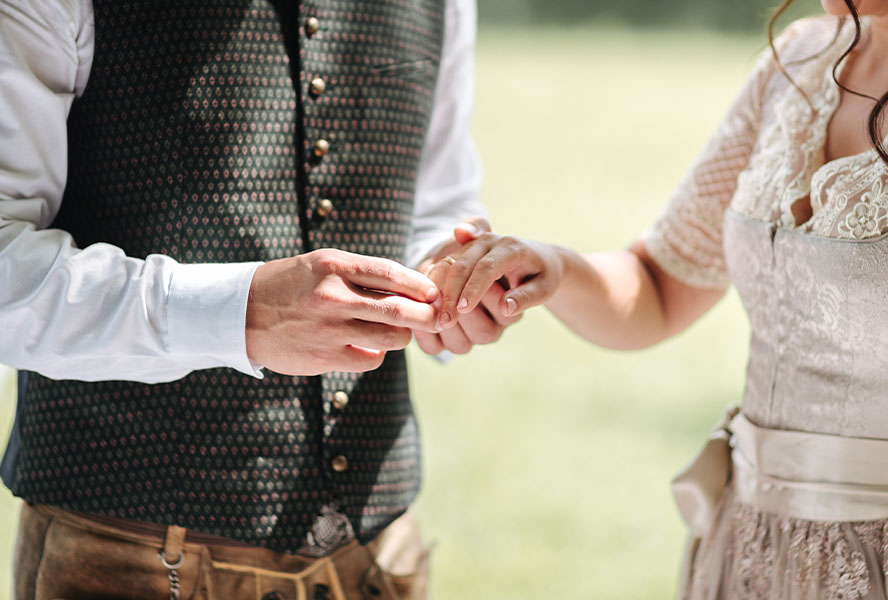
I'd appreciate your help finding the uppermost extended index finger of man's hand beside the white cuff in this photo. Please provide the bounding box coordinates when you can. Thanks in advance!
[345,254,438,302]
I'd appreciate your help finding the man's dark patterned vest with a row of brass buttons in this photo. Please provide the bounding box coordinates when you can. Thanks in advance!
[4,0,443,552]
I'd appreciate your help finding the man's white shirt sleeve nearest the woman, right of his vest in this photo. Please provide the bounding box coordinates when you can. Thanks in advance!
[406,0,487,267]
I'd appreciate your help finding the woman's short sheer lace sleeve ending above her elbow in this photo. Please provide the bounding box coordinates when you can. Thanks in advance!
[642,43,775,289]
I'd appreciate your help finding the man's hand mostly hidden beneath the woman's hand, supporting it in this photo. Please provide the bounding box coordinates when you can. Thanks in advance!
[413,217,521,354]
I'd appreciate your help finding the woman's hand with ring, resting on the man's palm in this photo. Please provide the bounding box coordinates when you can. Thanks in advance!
[427,232,565,330]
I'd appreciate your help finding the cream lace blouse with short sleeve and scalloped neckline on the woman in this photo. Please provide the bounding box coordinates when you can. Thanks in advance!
[644,16,888,288]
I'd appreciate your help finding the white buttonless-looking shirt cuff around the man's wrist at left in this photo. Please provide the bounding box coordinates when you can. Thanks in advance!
[167,262,262,378]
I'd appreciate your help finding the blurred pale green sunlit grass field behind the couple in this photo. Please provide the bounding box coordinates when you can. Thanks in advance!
[0,28,762,600]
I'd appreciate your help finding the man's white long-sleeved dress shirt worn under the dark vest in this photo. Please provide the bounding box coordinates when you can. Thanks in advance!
[0,0,484,383]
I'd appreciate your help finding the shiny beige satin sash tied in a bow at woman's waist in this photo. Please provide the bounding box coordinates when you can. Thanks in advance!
[672,408,888,597]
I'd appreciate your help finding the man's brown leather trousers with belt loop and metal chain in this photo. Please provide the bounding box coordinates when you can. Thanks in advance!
[14,504,429,600]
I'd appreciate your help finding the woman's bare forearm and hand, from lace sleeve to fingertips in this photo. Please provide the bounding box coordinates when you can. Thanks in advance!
[420,225,724,350]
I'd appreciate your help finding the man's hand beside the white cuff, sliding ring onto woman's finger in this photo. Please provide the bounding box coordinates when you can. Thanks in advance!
[246,250,439,375]
